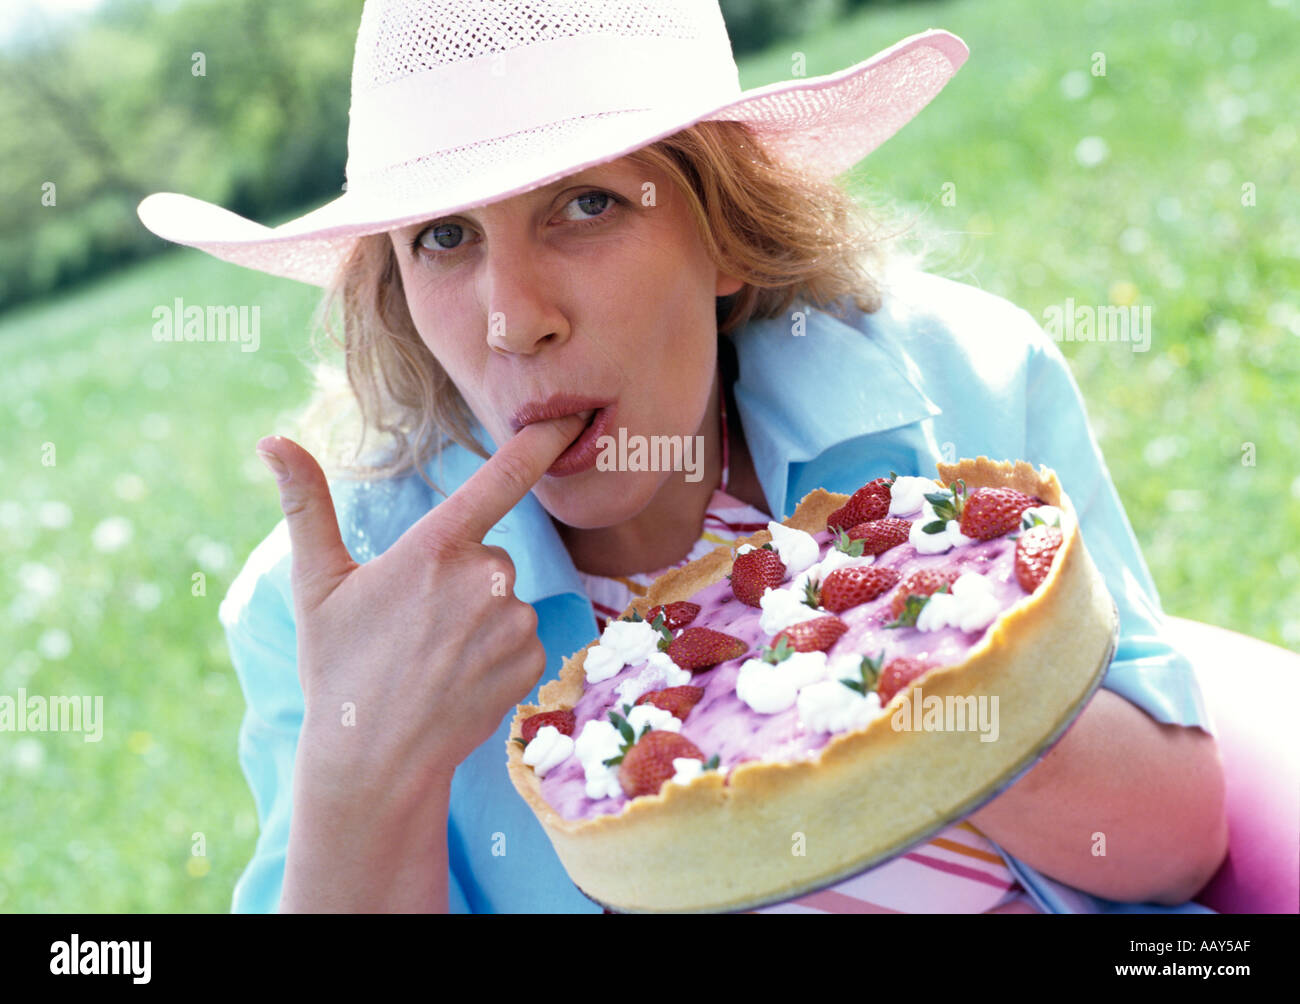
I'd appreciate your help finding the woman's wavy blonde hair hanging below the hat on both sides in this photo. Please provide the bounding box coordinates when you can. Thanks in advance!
[298,122,915,490]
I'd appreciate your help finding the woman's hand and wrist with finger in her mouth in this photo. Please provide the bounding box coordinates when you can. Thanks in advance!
[257,416,582,909]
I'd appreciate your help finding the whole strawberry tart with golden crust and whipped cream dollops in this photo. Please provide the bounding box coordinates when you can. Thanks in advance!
[507,456,1118,912]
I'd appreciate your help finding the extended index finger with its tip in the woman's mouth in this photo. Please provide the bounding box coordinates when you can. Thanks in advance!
[428,415,584,544]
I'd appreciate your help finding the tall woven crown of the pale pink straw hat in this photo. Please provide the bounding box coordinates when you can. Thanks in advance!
[347,0,741,187]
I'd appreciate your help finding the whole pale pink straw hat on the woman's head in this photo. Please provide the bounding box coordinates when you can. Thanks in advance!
[138,0,969,286]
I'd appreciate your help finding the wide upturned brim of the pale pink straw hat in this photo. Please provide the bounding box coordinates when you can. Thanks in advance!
[137,29,970,286]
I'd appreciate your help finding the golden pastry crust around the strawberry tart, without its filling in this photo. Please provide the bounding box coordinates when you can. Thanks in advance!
[506,456,1118,913]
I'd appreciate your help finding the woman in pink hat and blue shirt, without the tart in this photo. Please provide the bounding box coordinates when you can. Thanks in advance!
[140,0,1226,912]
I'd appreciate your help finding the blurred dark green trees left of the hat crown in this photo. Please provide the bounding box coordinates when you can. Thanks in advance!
[0,0,360,307]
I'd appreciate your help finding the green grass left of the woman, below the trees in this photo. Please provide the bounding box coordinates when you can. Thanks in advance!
[0,252,315,912]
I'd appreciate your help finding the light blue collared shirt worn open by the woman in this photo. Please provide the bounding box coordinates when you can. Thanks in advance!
[220,273,1210,913]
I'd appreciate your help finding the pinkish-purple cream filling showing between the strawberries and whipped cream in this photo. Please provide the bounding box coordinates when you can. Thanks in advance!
[542,531,1027,819]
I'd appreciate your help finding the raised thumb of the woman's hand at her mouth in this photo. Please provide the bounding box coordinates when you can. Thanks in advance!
[257,436,356,609]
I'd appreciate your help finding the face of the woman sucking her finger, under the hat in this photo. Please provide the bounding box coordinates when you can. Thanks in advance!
[391,159,742,528]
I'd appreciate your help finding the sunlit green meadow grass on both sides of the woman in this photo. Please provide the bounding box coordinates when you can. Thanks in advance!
[0,0,1300,912]
